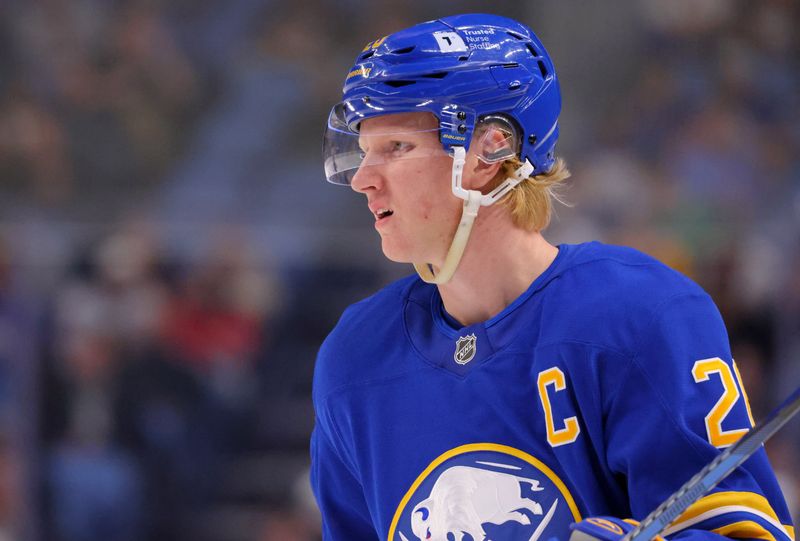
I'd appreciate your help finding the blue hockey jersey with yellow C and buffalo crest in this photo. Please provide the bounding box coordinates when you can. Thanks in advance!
[311,243,794,541]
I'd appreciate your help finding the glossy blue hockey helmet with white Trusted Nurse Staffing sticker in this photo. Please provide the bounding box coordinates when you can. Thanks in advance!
[323,14,561,184]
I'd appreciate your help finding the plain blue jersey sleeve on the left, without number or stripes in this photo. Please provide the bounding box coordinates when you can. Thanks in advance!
[311,423,378,541]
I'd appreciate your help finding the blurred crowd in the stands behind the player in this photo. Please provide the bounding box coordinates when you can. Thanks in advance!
[0,0,800,541]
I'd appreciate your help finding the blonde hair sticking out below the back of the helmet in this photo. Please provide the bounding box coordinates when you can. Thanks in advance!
[490,156,571,231]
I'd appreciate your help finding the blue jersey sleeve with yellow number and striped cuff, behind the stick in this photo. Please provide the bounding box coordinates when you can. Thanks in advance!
[603,293,794,541]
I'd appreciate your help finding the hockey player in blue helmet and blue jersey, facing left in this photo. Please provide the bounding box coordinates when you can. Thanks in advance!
[312,15,794,541]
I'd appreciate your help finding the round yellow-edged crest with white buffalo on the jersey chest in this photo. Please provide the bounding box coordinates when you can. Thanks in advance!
[389,444,580,541]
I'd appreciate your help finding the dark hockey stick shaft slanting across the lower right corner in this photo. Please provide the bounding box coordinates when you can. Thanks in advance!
[620,388,800,541]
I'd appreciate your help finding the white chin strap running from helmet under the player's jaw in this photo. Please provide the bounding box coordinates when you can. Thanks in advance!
[414,147,533,284]
